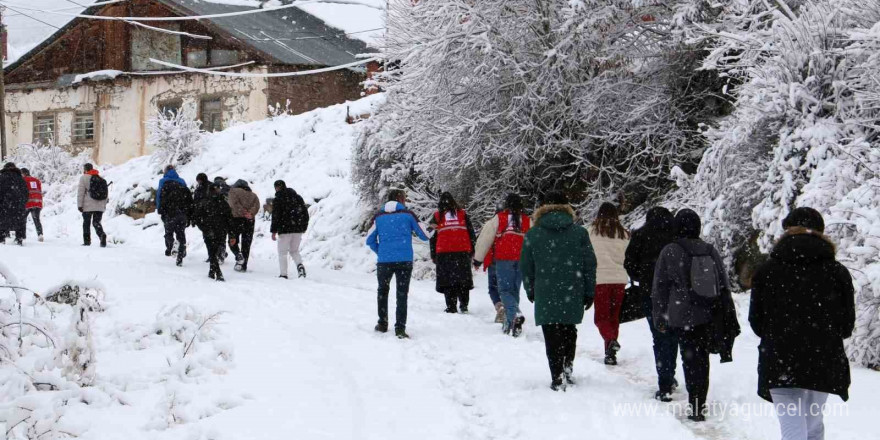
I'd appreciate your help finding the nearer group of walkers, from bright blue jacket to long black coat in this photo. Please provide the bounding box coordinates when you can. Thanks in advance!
[367,190,855,440]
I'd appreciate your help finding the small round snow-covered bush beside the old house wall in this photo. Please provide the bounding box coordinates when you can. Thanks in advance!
[146,107,204,168]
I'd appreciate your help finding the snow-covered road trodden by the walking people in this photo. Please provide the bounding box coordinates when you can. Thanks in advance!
[0,239,880,440]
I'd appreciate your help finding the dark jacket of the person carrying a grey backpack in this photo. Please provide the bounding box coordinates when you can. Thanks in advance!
[651,239,730,328]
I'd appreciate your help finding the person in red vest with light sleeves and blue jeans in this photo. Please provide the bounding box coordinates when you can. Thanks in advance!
[474,194,532,337]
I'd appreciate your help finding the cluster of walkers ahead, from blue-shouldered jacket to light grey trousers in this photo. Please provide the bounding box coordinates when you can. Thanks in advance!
[156,165,309,281]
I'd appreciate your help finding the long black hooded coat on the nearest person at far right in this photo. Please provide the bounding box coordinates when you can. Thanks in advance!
[749,228,855,401]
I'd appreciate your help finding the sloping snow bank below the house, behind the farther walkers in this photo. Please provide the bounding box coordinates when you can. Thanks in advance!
[28,95,385,271]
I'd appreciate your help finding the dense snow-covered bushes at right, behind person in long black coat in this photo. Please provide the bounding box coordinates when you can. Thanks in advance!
[671,0,880,365]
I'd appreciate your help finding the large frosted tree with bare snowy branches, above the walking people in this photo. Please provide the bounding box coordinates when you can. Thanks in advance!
[354,0,720,218]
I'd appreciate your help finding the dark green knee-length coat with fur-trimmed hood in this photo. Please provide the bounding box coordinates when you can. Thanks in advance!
[519,205,596,325]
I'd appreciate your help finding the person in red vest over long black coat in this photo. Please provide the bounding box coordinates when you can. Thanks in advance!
[430,192,476,313]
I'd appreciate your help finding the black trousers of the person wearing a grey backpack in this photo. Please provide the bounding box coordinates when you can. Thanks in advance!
[675,324,712,413]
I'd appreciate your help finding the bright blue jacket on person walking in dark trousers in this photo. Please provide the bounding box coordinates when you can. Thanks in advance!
[367,202,428,263]
